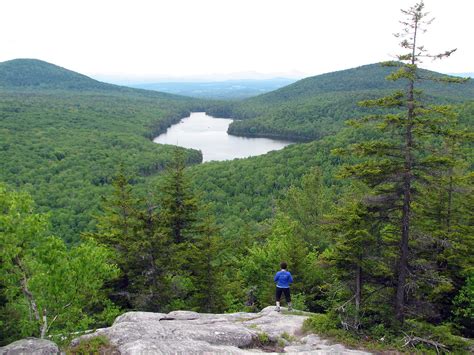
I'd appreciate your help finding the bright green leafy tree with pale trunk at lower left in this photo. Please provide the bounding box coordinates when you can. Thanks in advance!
[0,185,118,342]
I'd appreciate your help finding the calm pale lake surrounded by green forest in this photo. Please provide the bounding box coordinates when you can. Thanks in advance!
[153,112,292,162]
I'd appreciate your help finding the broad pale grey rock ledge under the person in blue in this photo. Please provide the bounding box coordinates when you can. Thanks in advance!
[71,307,368,354]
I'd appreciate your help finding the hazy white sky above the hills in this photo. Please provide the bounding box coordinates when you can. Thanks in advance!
[0,0,474,79]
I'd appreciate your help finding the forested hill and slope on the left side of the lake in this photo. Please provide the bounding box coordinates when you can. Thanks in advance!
[0,60,205,241]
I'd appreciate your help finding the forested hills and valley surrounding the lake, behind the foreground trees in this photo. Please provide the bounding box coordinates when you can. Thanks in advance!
[0,60,474,242]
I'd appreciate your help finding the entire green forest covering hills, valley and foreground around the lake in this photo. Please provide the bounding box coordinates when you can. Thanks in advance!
[0,5,474,353]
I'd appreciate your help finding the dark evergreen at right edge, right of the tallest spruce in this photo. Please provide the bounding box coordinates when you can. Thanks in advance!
[415,138,474,322]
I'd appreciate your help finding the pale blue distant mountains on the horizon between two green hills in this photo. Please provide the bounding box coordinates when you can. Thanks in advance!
[128,78,296,99]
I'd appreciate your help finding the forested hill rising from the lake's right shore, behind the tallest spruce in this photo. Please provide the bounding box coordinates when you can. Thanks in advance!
[208,63,474,140]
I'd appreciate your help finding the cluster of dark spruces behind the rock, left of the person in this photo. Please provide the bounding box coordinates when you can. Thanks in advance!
[85,154,225,312]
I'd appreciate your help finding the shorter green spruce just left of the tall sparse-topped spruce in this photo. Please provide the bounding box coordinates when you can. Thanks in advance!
[321,199,387,330]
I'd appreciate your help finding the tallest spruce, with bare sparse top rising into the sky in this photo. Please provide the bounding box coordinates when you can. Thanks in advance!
[336,1,463,322]
